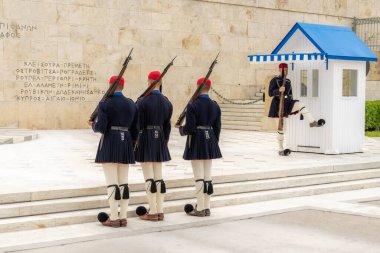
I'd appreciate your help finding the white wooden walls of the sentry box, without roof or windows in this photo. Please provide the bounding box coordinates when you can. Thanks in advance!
[279,30,365,154]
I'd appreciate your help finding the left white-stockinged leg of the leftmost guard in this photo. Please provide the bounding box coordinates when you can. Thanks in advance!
[103,163,120,221]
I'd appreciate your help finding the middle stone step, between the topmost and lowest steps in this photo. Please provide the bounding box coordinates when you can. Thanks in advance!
[0,169,380,218]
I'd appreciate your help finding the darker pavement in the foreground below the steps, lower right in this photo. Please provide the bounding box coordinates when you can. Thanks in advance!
[13,210,380,253]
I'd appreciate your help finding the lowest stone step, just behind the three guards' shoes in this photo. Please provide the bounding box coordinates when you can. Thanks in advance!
[0,178,380,232]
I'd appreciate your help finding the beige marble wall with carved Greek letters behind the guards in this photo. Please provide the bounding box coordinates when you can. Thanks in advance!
[0,0,380,129]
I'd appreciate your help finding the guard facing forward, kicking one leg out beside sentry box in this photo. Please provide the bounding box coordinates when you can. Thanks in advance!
[268,63,325,156]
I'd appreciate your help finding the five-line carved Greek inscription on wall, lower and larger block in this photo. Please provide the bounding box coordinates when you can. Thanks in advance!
[15,61,105,102]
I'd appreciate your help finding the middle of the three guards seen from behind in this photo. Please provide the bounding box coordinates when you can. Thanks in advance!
[135,71,173,221]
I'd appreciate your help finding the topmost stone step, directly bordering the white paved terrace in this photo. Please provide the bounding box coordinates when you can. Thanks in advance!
[0,162,380,204]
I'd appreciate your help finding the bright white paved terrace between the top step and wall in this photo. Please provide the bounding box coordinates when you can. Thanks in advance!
[0,129,380,193]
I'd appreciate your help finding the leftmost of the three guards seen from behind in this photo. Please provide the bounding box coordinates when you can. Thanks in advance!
[89,76,138,227]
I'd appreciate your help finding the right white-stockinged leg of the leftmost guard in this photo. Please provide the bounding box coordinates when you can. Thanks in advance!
[117,164,129,226]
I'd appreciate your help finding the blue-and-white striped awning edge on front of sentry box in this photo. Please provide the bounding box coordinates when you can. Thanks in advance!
[248,53,326,63]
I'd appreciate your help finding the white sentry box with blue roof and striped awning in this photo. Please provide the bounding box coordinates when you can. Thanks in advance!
[248,23,377,154]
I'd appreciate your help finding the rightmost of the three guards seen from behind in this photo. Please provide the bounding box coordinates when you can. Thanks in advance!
[179,78,222,217]
